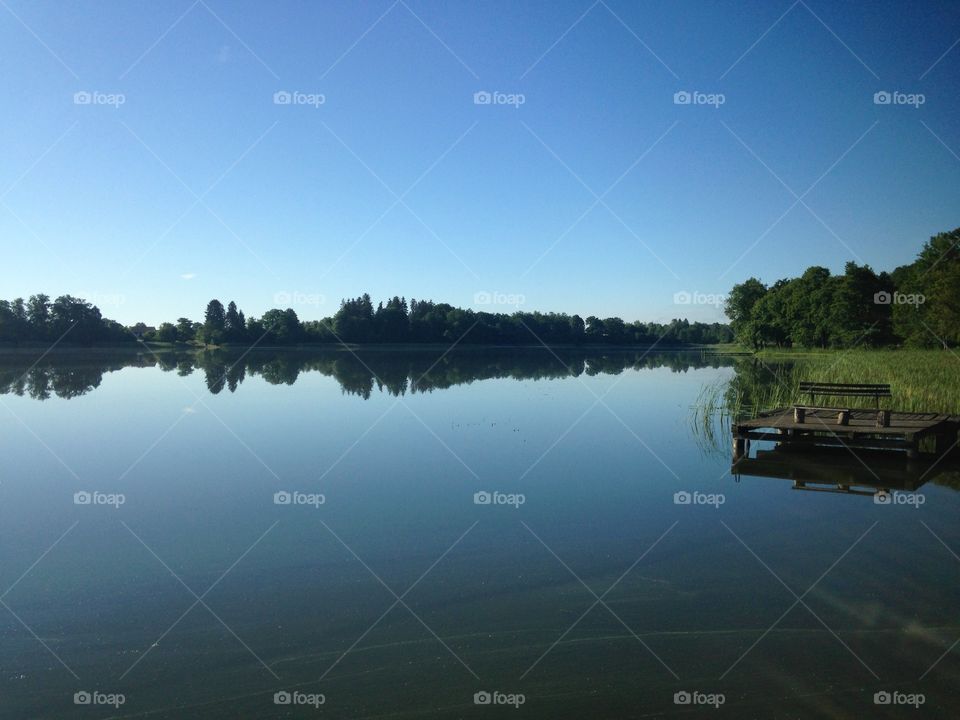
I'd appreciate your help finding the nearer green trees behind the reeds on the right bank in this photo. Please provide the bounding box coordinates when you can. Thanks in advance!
[725,228,960,349]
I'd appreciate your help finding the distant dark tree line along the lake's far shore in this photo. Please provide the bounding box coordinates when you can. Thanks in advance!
[0,294,733,346]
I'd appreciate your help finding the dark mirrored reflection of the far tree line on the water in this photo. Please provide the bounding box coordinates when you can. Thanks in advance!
[0,348,736,400]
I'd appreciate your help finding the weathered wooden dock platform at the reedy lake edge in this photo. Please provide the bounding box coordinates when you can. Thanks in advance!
[732,407,960,459]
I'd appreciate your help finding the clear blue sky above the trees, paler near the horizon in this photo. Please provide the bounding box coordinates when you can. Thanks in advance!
[0,0,960,324]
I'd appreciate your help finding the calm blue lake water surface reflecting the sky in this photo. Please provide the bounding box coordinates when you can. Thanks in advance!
[0,351,960,718]
